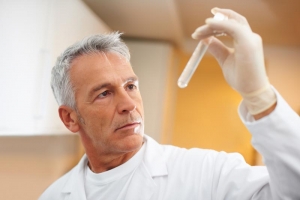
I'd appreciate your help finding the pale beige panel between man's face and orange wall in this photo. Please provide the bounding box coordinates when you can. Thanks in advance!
[125,40,177,142]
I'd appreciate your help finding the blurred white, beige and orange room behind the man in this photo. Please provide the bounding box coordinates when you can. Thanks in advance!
[0,0,300,199]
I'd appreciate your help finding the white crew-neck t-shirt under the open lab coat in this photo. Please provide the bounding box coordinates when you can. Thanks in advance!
[85,144,145,200]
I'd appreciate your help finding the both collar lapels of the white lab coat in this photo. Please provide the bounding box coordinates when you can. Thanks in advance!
[62,135,168,200]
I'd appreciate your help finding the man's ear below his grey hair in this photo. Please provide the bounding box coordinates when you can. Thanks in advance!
[58,106,80,133]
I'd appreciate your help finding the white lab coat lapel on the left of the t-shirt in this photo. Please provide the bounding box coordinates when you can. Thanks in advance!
[62,155,87,200]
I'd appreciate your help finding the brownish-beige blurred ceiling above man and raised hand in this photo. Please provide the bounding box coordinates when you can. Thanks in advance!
[83,0,300,51]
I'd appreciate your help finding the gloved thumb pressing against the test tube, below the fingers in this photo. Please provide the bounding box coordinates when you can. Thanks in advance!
[204,37,233,67]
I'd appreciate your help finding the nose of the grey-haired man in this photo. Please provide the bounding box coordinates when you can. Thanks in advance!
[117,91,136,114]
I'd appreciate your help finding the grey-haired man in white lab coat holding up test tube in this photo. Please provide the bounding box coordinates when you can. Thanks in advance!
[40,8,300,200]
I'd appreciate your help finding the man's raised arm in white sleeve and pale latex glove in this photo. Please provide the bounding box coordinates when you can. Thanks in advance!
[192,8,300,200]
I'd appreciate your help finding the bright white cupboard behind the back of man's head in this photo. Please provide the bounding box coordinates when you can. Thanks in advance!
[0,0,109,135]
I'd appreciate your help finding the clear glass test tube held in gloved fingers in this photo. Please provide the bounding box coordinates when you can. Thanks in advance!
[177,13,227,88]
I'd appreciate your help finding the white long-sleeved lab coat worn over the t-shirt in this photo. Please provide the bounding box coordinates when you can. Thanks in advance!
[40,89,300,200]
